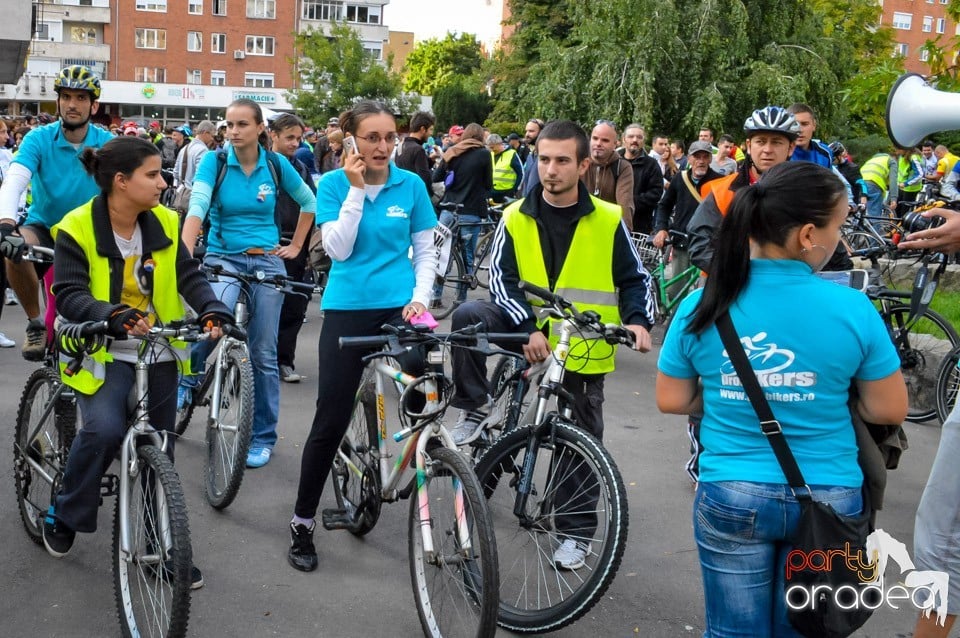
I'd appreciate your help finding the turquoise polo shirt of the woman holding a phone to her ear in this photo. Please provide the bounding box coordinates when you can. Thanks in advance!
[317,164,437,310]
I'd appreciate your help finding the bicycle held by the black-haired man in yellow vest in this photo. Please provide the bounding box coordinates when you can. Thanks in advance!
[476,282,633,633]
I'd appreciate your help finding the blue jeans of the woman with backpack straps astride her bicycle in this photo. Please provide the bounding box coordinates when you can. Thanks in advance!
[190,253,287,448]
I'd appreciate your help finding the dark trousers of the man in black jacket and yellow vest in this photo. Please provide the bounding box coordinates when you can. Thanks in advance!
[450,301,605,542]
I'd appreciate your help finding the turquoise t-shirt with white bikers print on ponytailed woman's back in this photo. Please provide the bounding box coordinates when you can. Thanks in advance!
[658,259,900,487]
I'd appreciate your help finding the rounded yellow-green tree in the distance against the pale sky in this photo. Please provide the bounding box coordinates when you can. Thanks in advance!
[404,33,483,95]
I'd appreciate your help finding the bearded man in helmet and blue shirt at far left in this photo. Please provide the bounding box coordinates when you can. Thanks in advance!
[0,65,113,361]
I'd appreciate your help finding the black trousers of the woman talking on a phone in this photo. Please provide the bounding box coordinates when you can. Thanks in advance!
[294,308,425,518]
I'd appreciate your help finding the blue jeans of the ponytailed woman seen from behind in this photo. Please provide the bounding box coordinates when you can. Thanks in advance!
[693,481,863,638]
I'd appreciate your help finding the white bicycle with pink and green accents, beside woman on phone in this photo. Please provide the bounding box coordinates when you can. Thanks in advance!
[330,326,526,636]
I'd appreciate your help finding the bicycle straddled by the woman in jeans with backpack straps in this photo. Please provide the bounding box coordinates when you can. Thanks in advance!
[175,265,313,509]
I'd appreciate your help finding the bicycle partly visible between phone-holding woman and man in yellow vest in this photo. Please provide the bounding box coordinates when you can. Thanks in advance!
[430,203,497,319]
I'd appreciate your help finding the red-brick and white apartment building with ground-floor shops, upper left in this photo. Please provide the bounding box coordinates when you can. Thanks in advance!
[0,0,389,125]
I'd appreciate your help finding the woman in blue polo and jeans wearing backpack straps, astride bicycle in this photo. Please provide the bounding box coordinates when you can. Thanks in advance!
[183,99,316,467]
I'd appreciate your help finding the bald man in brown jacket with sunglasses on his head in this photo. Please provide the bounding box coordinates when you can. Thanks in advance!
[583,120,632,230]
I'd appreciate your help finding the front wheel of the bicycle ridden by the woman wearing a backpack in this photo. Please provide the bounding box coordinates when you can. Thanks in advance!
[204,344,253,510]
